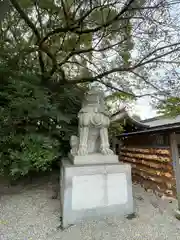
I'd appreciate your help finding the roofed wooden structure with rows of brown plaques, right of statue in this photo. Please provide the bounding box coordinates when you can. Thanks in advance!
[112,109,180,209]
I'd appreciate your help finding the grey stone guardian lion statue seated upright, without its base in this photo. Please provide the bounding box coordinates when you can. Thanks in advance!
[70,88,114,156]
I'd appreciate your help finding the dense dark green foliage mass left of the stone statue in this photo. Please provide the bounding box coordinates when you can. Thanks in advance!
[0,66,82,179]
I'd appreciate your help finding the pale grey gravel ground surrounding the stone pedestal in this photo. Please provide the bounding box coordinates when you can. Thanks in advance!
[0,176,180,240]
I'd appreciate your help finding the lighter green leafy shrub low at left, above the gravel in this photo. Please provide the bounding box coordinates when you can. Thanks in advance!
[0,134,59,179]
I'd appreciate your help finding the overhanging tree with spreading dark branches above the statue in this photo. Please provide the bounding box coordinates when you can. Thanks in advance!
[3,0,180,97]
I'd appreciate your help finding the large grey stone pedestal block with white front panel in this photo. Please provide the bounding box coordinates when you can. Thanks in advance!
[60,159,134,228]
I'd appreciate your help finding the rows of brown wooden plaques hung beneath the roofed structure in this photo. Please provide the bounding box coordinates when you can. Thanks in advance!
[119,146,176,197]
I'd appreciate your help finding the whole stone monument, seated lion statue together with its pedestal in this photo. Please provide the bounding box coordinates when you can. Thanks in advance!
[60,88,134,228]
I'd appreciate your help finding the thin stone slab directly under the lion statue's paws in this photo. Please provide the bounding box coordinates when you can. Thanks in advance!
[69,153,119,165]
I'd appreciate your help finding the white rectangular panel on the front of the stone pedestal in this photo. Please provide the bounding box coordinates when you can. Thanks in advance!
[72,173,128,210]
